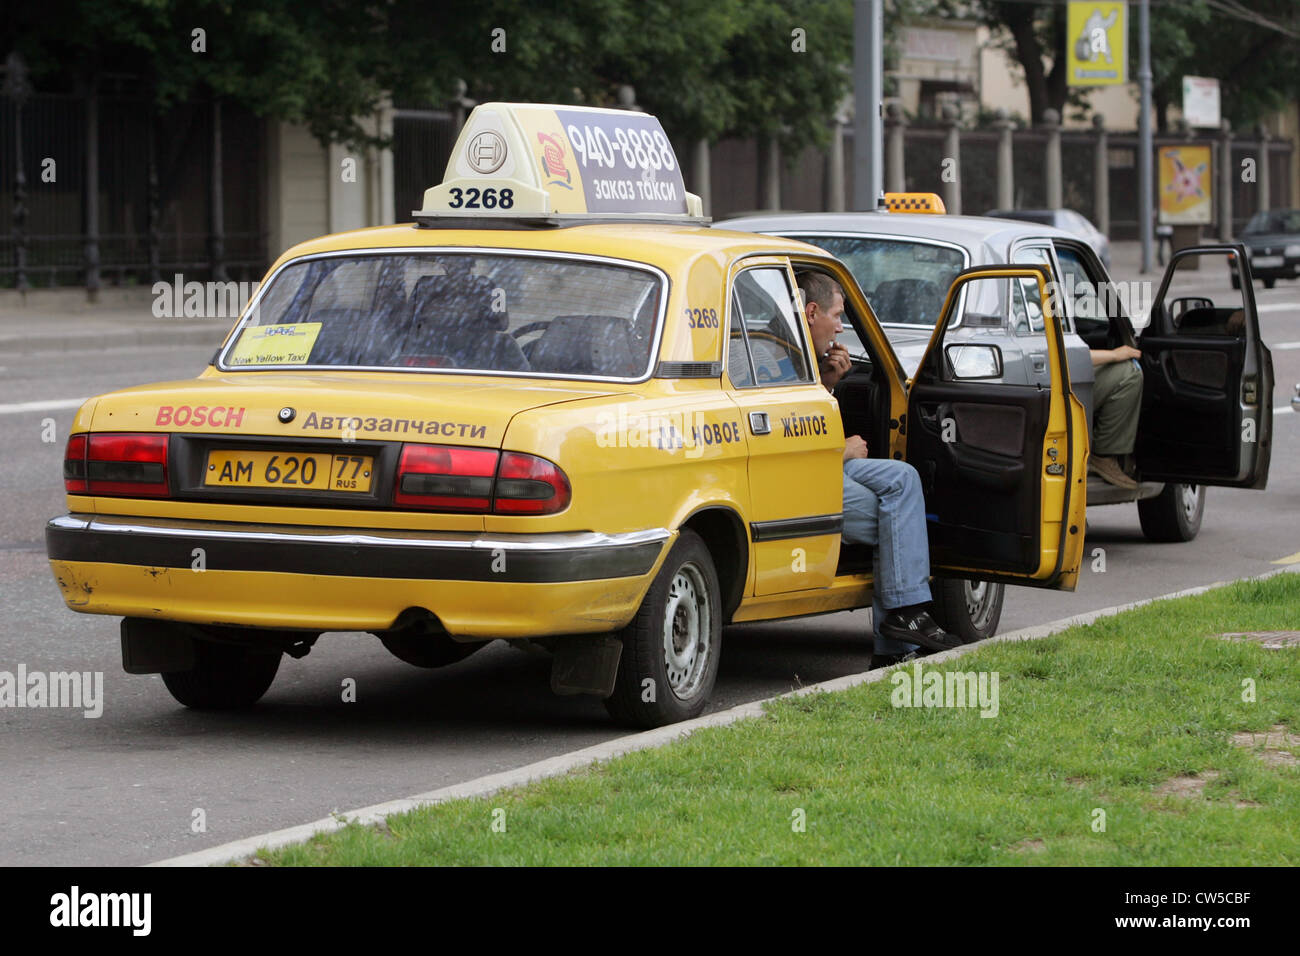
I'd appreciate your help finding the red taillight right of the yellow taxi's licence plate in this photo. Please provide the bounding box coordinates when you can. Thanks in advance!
[393,445,572,515]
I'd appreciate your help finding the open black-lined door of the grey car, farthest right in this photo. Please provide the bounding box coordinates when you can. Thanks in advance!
[1136,243,1273,488]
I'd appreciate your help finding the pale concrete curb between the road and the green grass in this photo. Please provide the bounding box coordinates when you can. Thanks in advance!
[148,564,1300,866]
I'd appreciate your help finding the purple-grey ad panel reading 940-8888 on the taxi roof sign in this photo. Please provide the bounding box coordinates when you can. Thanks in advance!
[555,109,686,213]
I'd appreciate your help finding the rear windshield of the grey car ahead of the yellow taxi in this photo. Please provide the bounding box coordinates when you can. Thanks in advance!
[798,235,966,325]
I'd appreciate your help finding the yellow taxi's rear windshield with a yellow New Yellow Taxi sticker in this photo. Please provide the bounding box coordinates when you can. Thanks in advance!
[220,252,664,378]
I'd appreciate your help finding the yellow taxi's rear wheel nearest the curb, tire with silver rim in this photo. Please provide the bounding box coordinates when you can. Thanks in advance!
[605,528,722,727]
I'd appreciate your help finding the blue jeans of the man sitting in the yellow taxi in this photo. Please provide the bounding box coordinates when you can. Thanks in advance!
[842,458,931,654]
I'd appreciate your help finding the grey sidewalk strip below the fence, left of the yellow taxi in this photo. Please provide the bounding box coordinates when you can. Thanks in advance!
[0,289,235,358]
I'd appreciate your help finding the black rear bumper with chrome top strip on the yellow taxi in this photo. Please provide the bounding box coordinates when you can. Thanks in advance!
[46,515,668,584]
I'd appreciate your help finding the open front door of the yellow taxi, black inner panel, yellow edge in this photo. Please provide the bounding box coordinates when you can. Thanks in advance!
[896,265,1088,591]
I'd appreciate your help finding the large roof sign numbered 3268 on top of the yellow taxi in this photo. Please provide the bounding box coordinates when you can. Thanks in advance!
[413,103,709,226]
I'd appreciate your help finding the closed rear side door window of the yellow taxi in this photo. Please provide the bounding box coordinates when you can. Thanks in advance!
[732,267,813,385]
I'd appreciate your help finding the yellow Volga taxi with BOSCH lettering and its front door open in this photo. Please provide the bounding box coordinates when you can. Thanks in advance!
[47,103,1088,726]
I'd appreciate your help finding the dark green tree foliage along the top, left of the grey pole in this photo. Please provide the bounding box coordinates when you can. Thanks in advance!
[0,0,853,153]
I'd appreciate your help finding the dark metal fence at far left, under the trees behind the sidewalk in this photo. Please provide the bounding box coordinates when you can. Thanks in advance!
[0,90,267,289]
